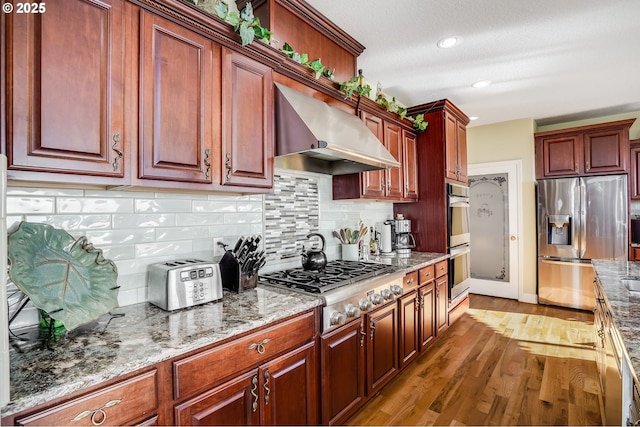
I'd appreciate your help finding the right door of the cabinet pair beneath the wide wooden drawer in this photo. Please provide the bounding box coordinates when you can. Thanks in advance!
[260,342,320,426]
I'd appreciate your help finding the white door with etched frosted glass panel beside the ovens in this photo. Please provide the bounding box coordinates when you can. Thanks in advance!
[469,160,523,299]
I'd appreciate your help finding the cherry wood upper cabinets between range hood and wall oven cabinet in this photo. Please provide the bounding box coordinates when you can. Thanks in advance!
[333,111,418,201]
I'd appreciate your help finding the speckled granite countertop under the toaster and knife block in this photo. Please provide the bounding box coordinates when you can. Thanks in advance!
[1,287,322,417]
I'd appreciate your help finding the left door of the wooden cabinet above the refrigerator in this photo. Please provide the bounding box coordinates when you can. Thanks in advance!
[536,134,582,178]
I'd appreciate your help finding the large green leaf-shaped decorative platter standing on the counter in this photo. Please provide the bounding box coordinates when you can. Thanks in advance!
[7,221,118,330]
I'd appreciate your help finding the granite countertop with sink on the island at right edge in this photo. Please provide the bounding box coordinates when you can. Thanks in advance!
[592,260,640,382]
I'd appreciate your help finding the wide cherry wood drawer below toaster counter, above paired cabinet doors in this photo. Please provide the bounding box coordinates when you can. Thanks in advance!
[173,311,316,399]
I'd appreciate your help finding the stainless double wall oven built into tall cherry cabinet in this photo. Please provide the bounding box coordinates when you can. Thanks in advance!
[447,184,471,305]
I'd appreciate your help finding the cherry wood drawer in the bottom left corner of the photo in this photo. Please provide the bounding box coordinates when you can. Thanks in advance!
[16,369,158,426]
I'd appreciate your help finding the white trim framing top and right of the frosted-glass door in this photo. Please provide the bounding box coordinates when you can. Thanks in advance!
[467,160,530,302]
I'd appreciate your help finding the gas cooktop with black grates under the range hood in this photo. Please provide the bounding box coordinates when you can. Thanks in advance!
[259,261,396,294]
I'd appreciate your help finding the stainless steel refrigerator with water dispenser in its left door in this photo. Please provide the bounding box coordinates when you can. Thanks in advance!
[537,175,628,310]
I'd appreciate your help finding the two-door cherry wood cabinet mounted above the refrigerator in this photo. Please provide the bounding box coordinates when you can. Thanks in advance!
[535,119,635,179]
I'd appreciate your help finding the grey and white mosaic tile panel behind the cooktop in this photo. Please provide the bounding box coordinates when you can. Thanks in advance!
[264,174,320,260]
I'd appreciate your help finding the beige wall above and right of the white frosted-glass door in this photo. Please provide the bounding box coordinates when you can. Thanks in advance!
[467,119,537,302]
